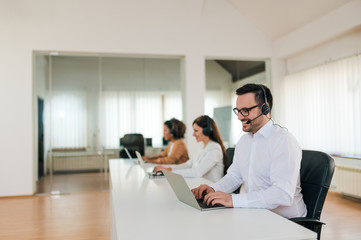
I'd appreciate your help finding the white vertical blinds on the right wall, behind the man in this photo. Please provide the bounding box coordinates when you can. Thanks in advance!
[284,55,361,157]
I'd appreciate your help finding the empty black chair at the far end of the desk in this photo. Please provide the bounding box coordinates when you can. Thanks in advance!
[119,133,144,158]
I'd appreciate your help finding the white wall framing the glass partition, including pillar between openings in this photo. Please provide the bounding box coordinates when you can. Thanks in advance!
[0,0,272,196]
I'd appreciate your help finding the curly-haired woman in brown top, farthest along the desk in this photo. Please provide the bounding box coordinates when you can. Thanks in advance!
[143,118,189,164]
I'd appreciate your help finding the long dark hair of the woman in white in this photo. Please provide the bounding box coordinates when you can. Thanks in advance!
[192,115,227,166]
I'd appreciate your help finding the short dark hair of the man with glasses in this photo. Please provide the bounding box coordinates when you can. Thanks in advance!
[236,83,273,110]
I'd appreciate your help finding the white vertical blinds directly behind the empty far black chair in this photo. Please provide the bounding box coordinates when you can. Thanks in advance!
[101,91,182,147]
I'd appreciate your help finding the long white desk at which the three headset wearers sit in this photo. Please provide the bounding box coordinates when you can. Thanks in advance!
[109,159,316,240]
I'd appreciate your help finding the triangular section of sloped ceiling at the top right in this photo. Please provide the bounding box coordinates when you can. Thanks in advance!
[228,0,352,40]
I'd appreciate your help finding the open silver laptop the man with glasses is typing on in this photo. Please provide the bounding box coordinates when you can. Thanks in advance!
[163,171,226,211]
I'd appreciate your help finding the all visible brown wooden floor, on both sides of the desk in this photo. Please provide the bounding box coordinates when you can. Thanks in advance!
[0,173,361,240]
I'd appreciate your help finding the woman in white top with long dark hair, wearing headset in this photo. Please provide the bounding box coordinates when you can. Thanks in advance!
[153,115,227,182]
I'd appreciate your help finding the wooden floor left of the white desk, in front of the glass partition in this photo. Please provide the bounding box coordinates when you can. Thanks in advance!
[0,192,110,240]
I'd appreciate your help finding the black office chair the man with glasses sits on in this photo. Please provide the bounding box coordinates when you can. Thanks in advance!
[290,150,335,239]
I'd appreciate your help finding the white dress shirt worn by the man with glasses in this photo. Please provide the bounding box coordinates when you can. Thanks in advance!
[211,121,307,218]
